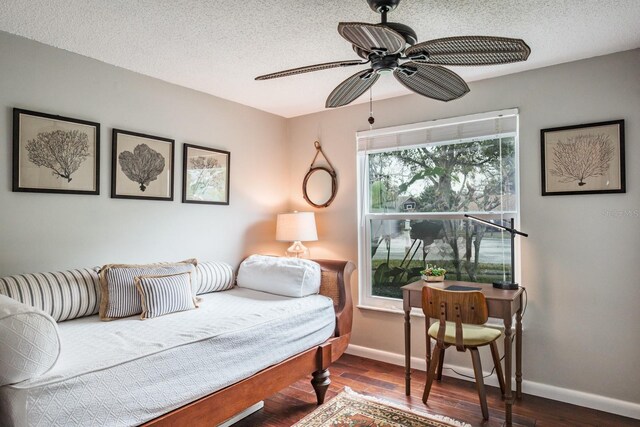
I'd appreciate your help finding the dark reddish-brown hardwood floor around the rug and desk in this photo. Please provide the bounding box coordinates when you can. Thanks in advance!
[235,354,640,427]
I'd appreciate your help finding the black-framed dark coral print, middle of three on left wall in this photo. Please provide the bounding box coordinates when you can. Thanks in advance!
[111,129,175,201]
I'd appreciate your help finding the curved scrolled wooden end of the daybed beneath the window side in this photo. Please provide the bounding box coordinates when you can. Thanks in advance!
[313,259,355,337]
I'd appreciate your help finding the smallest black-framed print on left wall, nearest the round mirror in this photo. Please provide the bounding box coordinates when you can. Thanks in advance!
[182,144,231,205]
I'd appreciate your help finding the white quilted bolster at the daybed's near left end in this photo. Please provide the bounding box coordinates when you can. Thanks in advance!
[0,295,60,386]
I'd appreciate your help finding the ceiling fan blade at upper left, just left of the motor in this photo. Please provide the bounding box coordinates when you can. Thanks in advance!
[338,22,406,55]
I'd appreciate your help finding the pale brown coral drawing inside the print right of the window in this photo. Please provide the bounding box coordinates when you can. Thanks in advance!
[549,134,615,187]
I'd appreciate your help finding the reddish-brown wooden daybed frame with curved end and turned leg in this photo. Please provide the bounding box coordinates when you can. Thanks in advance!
[143,260,355,427]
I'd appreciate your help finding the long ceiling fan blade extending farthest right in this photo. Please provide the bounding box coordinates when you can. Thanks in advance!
[405,36,531,65]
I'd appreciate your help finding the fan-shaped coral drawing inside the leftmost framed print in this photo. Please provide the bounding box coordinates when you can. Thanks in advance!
[25,130,90,182]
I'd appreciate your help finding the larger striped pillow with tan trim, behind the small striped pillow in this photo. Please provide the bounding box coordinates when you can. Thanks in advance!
[99,260,197,320]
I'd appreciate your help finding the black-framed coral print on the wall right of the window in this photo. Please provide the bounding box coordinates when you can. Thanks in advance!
[540,120,626,196]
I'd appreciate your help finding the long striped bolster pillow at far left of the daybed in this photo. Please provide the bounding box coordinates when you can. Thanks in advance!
[0,268,100,322]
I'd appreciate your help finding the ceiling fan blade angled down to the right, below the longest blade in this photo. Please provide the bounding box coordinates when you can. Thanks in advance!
[393,62,469,101]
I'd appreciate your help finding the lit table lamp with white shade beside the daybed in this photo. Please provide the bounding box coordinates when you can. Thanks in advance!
[276,211,318,258]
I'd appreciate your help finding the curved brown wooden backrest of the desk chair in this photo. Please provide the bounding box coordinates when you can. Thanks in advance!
[422,286,489,325]
